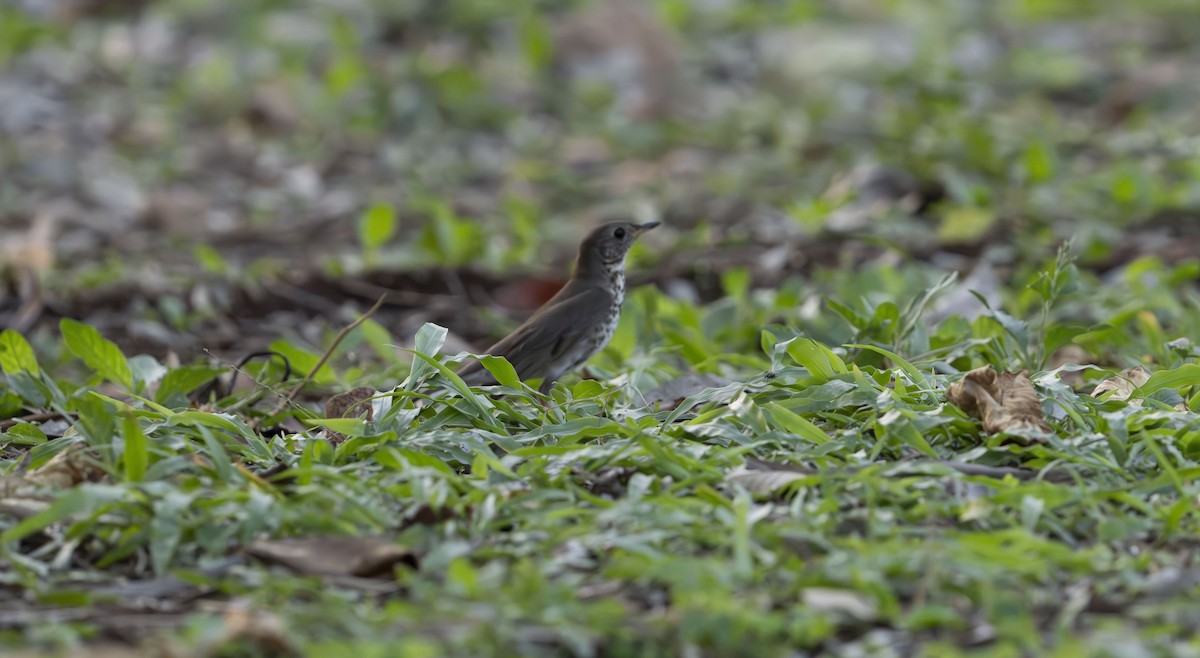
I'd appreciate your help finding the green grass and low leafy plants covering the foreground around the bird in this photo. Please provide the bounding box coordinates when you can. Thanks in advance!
[0,249,1200,654]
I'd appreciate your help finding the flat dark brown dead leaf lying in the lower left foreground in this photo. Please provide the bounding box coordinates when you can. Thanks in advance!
[246,537,416,578]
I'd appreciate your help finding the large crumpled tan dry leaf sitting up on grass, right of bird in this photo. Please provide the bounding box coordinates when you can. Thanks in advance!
[946,365,1051,441]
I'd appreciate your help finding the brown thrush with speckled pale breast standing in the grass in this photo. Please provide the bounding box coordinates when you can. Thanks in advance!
[458,222,659,393]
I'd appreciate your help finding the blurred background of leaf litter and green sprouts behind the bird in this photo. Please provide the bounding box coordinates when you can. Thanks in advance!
[0,0,1200,365]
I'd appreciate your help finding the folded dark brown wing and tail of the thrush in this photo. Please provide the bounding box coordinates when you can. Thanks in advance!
[458,287,612,384]
